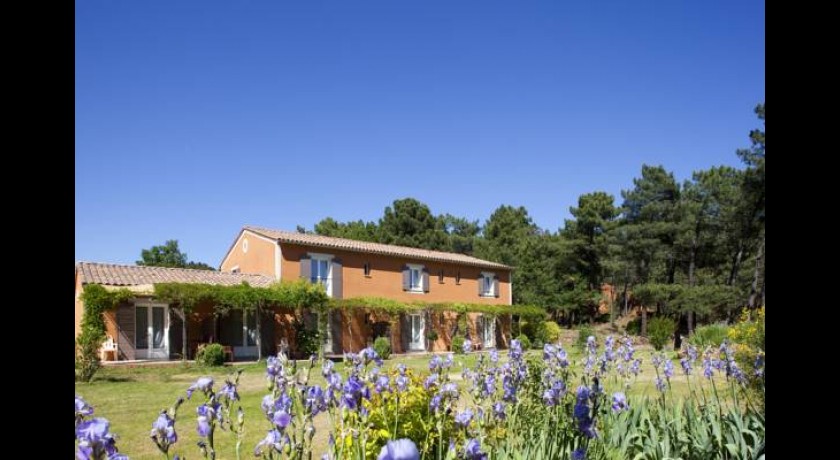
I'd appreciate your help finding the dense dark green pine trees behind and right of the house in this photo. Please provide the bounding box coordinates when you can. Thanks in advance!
[298,103,766,333]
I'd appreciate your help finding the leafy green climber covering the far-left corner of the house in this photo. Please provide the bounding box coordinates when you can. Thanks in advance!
[76,284,134,382]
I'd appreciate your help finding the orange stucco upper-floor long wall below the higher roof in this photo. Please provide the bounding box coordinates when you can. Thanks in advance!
[278,243,510,305]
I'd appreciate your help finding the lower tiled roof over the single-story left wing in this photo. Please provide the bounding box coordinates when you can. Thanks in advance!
[76,262,274,287]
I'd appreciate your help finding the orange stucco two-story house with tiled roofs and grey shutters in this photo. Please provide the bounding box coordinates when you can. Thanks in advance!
[76,226,512,359]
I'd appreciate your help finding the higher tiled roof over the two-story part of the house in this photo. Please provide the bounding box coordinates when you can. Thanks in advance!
[244,225,511,270]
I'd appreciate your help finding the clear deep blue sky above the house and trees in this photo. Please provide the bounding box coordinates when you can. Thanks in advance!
[75,0,765,265]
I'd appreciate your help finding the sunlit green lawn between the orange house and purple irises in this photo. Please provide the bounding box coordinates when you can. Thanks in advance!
[76,347,720,460]
